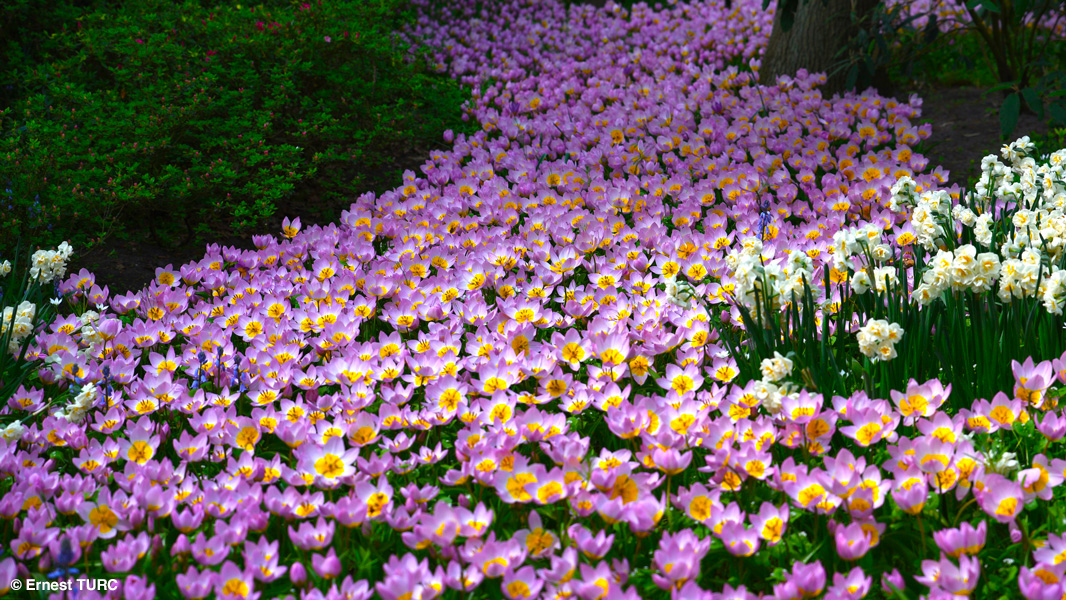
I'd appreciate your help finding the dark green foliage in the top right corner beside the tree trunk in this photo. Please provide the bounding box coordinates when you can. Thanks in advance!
[814,0,1066,140]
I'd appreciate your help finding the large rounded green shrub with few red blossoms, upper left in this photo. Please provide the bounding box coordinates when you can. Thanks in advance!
[0,0,475,247]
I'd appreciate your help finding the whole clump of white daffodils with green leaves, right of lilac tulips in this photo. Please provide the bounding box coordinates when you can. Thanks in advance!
[718,139,1066,406]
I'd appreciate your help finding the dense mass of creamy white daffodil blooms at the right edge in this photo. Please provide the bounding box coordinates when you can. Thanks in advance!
[865,136,1066,314]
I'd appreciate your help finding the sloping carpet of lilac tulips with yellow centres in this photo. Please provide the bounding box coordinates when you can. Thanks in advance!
[6,1,1066,600]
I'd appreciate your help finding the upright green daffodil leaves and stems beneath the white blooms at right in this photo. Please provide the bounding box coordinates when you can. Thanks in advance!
[717,238,1066,406]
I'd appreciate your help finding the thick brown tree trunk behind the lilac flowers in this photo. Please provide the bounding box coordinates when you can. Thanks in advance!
[759,0,877,96]
